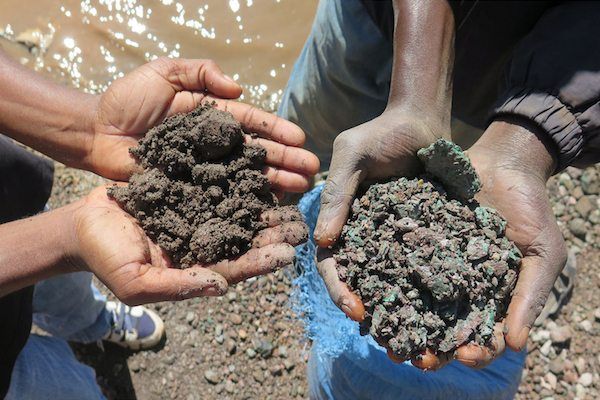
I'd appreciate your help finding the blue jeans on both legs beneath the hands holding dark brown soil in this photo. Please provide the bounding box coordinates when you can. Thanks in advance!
[6,272,111,400]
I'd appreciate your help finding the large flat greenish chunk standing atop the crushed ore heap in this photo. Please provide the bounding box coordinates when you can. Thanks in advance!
[417,139,481,201]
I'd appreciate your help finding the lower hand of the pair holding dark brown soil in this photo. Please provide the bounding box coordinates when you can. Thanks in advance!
[71,187,306,305]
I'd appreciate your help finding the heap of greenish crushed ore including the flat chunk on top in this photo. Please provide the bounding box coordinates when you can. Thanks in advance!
[334,140,521,359]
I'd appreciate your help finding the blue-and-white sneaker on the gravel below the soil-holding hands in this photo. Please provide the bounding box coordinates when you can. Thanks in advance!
[103,301,165,351]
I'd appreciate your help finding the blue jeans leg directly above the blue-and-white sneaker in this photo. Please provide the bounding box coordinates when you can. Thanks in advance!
[33,272,112,343]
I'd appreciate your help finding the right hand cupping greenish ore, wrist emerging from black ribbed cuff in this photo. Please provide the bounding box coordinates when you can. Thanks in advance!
[456,121,567,367]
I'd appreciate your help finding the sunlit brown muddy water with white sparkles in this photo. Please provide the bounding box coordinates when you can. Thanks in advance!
[0,0,317,109]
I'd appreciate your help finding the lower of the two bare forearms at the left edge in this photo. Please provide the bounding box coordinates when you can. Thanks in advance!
[0,203,78,297]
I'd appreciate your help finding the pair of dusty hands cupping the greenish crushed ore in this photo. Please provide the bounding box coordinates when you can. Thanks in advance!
[314,111,566,370]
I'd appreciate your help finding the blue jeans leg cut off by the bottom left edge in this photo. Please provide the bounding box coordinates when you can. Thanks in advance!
[6,335,105,400]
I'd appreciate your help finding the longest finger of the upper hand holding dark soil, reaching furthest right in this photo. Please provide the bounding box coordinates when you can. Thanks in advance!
[246,135,320,176]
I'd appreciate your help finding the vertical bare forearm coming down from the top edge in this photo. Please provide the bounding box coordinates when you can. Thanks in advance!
[386,0,454,131]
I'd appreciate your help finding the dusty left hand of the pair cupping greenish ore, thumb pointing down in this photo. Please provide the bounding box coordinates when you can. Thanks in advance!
[315,113,458,369]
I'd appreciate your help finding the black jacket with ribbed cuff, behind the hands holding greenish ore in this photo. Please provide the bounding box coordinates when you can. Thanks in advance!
[362,0,600,170]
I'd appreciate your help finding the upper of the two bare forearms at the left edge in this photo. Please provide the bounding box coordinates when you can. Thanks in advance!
[0,51,97,166]
